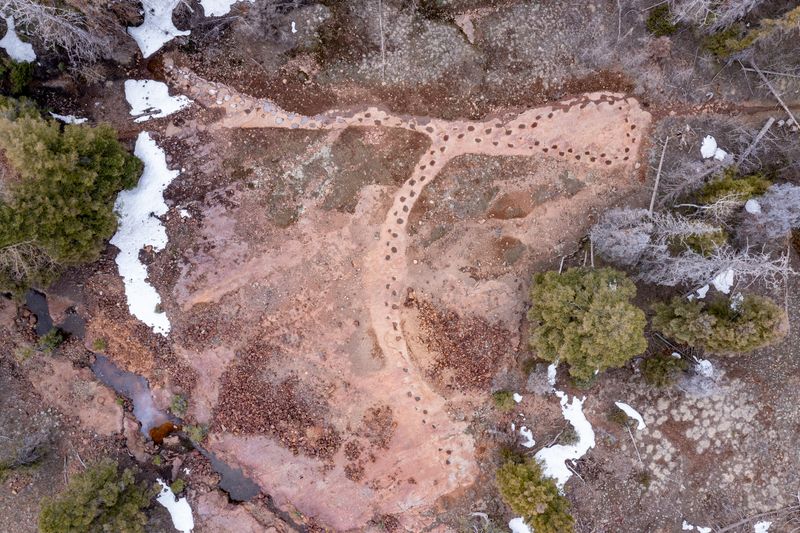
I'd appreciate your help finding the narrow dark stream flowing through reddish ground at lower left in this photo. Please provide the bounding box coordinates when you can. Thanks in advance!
[25,290,261,502]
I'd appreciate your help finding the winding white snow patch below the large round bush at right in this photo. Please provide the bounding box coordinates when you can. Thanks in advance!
[534,391,594,489]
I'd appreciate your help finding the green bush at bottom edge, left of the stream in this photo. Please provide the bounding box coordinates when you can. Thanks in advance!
[39,459,156,533]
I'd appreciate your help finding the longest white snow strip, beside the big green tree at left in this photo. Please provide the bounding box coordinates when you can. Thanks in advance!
[111,132,179,335]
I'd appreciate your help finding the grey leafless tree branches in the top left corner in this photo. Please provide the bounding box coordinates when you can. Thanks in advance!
[0,0,108,67]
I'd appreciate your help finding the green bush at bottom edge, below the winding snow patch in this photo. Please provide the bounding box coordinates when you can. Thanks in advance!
[497,458,574,533]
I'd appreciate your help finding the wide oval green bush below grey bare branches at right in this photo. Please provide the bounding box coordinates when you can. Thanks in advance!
[653,295,786,353]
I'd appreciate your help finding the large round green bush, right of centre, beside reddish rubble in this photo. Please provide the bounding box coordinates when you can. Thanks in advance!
[528,268,647,382]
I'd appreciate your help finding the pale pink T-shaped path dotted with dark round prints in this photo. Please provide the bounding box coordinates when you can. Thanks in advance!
[166,64,651,519]
